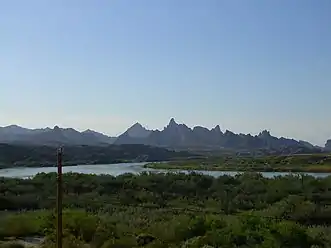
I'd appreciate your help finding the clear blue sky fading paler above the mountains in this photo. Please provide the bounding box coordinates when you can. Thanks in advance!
[0,0,331,145]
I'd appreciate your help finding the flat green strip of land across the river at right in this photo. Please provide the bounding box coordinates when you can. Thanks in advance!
[145,154,331,172]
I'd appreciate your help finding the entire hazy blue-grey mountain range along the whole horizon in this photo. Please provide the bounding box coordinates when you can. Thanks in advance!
[0,118,331,152]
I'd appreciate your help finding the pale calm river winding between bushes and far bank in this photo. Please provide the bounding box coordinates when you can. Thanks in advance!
[0,163,331,178]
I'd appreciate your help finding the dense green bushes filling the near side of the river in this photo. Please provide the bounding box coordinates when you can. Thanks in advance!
[0,173,331,248]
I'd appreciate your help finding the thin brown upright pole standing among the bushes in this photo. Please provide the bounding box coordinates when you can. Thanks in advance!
[56,147,63,248]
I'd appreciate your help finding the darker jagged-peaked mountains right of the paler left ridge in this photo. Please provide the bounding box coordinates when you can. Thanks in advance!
[114,118,321,153]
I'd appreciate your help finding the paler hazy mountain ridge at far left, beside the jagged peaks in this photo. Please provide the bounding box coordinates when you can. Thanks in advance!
[0,125,116,146]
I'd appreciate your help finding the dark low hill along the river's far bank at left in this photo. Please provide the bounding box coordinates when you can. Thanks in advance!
[0,144,190,168]
